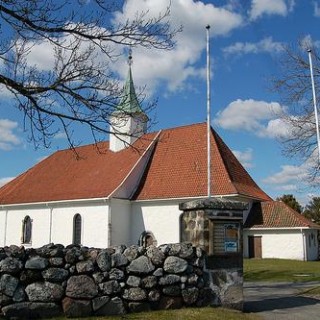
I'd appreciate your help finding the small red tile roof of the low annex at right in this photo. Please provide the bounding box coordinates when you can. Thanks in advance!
[244,201,320,229]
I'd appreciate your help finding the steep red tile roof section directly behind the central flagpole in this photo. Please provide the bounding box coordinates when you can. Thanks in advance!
[135,123,270,200]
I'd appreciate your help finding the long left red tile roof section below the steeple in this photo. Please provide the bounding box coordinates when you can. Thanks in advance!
[0,138,152,204]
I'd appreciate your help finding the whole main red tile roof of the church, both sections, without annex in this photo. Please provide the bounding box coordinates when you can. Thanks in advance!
[0,123,270,204]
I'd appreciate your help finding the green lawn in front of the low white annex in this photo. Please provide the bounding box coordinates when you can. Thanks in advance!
[244,259,320,282]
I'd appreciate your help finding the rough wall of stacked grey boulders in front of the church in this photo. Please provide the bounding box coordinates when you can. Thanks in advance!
[0,243,214,319]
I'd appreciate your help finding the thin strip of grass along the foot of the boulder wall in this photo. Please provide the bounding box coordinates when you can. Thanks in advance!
[47,307,261,320]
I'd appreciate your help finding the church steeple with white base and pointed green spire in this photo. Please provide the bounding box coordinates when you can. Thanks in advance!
[110,48,149,152]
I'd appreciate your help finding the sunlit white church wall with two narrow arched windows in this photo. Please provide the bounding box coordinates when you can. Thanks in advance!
[0,203,110,248]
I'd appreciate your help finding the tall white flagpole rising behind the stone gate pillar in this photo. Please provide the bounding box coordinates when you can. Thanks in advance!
[206,25,211,198]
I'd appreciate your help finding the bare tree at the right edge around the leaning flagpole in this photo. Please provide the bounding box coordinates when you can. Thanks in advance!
[273,40,320,182]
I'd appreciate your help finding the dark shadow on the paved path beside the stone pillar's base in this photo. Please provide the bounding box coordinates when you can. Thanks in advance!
[244,296,319,313]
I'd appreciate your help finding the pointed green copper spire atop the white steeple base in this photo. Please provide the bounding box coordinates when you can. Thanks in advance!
[117,49,143,114]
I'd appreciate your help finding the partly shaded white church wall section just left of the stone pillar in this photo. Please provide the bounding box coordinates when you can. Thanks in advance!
[131,200,182,245]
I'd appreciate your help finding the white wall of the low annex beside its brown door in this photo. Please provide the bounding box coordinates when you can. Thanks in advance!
[243,229,307,260]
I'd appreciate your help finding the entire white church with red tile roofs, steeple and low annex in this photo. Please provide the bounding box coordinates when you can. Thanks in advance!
[0,65,320,260]
